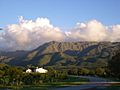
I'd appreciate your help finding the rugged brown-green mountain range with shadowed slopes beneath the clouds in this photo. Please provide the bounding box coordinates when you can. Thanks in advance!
[0,41,120,68]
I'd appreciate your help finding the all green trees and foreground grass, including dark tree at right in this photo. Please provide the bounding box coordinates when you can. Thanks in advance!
[0,53,120,90]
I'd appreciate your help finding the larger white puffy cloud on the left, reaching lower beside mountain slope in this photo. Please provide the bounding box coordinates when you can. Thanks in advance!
[0,16,64,50]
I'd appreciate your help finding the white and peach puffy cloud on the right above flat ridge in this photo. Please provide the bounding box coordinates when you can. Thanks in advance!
[65,20,120,42]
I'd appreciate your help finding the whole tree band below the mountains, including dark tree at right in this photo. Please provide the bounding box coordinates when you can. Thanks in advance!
[0,51,120,86]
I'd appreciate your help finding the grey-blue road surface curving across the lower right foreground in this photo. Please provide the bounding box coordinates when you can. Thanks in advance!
[53,76,120,90]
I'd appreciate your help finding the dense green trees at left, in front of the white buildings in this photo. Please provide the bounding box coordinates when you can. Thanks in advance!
[0,64,67,86]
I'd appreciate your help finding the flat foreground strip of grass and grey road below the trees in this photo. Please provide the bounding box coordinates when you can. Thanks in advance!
[0,76,120,90]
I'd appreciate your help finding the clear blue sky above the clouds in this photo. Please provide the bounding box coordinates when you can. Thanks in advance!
[0,0,120,28]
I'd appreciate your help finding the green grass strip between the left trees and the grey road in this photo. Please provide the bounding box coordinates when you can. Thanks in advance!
[0,76,89,90]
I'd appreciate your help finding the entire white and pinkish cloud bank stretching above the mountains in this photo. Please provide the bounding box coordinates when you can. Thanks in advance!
[0,16,120,51]
